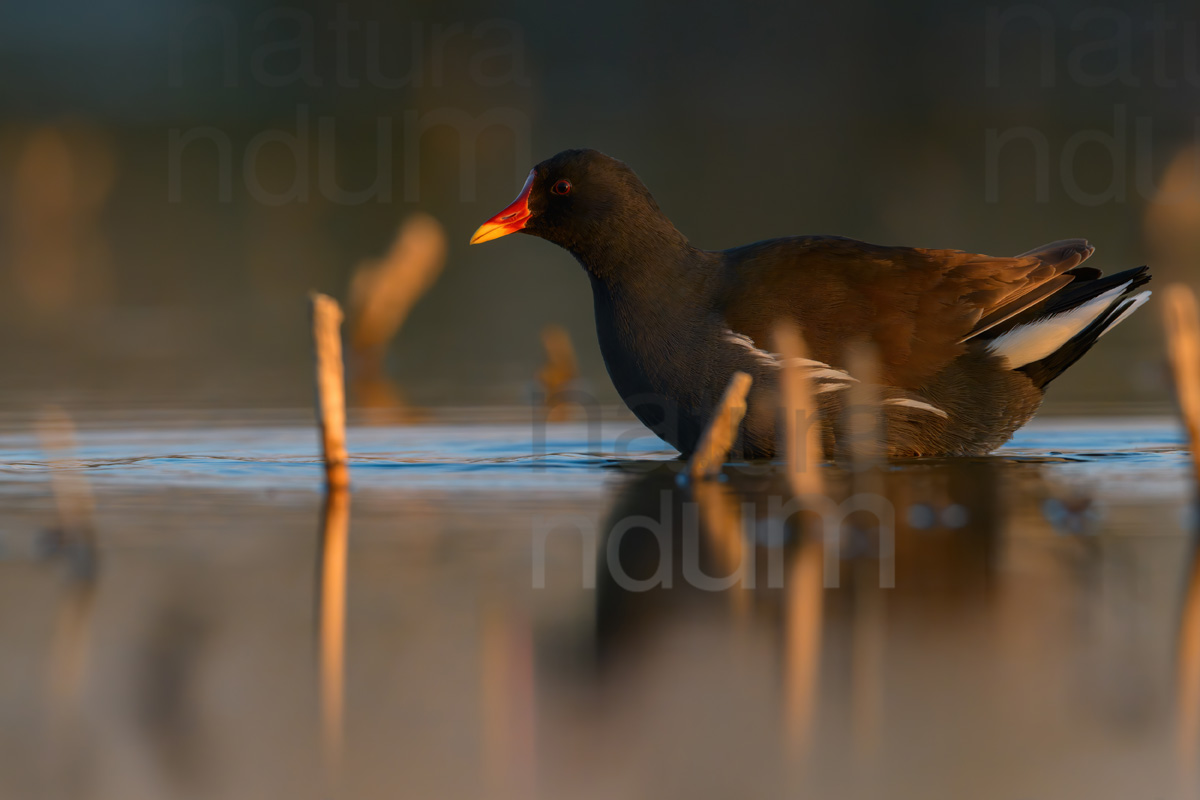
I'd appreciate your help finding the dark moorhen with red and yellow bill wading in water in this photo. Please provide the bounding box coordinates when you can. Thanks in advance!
[470,150,1150,458]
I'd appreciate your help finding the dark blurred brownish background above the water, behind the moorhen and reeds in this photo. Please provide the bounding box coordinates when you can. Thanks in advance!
[0,0,1200,413]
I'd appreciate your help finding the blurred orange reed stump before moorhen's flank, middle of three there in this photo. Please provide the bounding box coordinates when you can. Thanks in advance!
[774,323,824,497]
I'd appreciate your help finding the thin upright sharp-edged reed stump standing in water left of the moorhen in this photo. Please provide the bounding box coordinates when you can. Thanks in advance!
[310,291,350,491]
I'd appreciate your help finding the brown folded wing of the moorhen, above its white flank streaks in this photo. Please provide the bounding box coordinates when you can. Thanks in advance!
[721,236,1093,389]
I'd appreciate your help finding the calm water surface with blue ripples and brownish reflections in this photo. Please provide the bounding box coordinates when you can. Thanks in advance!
[0,413,1200,800]
